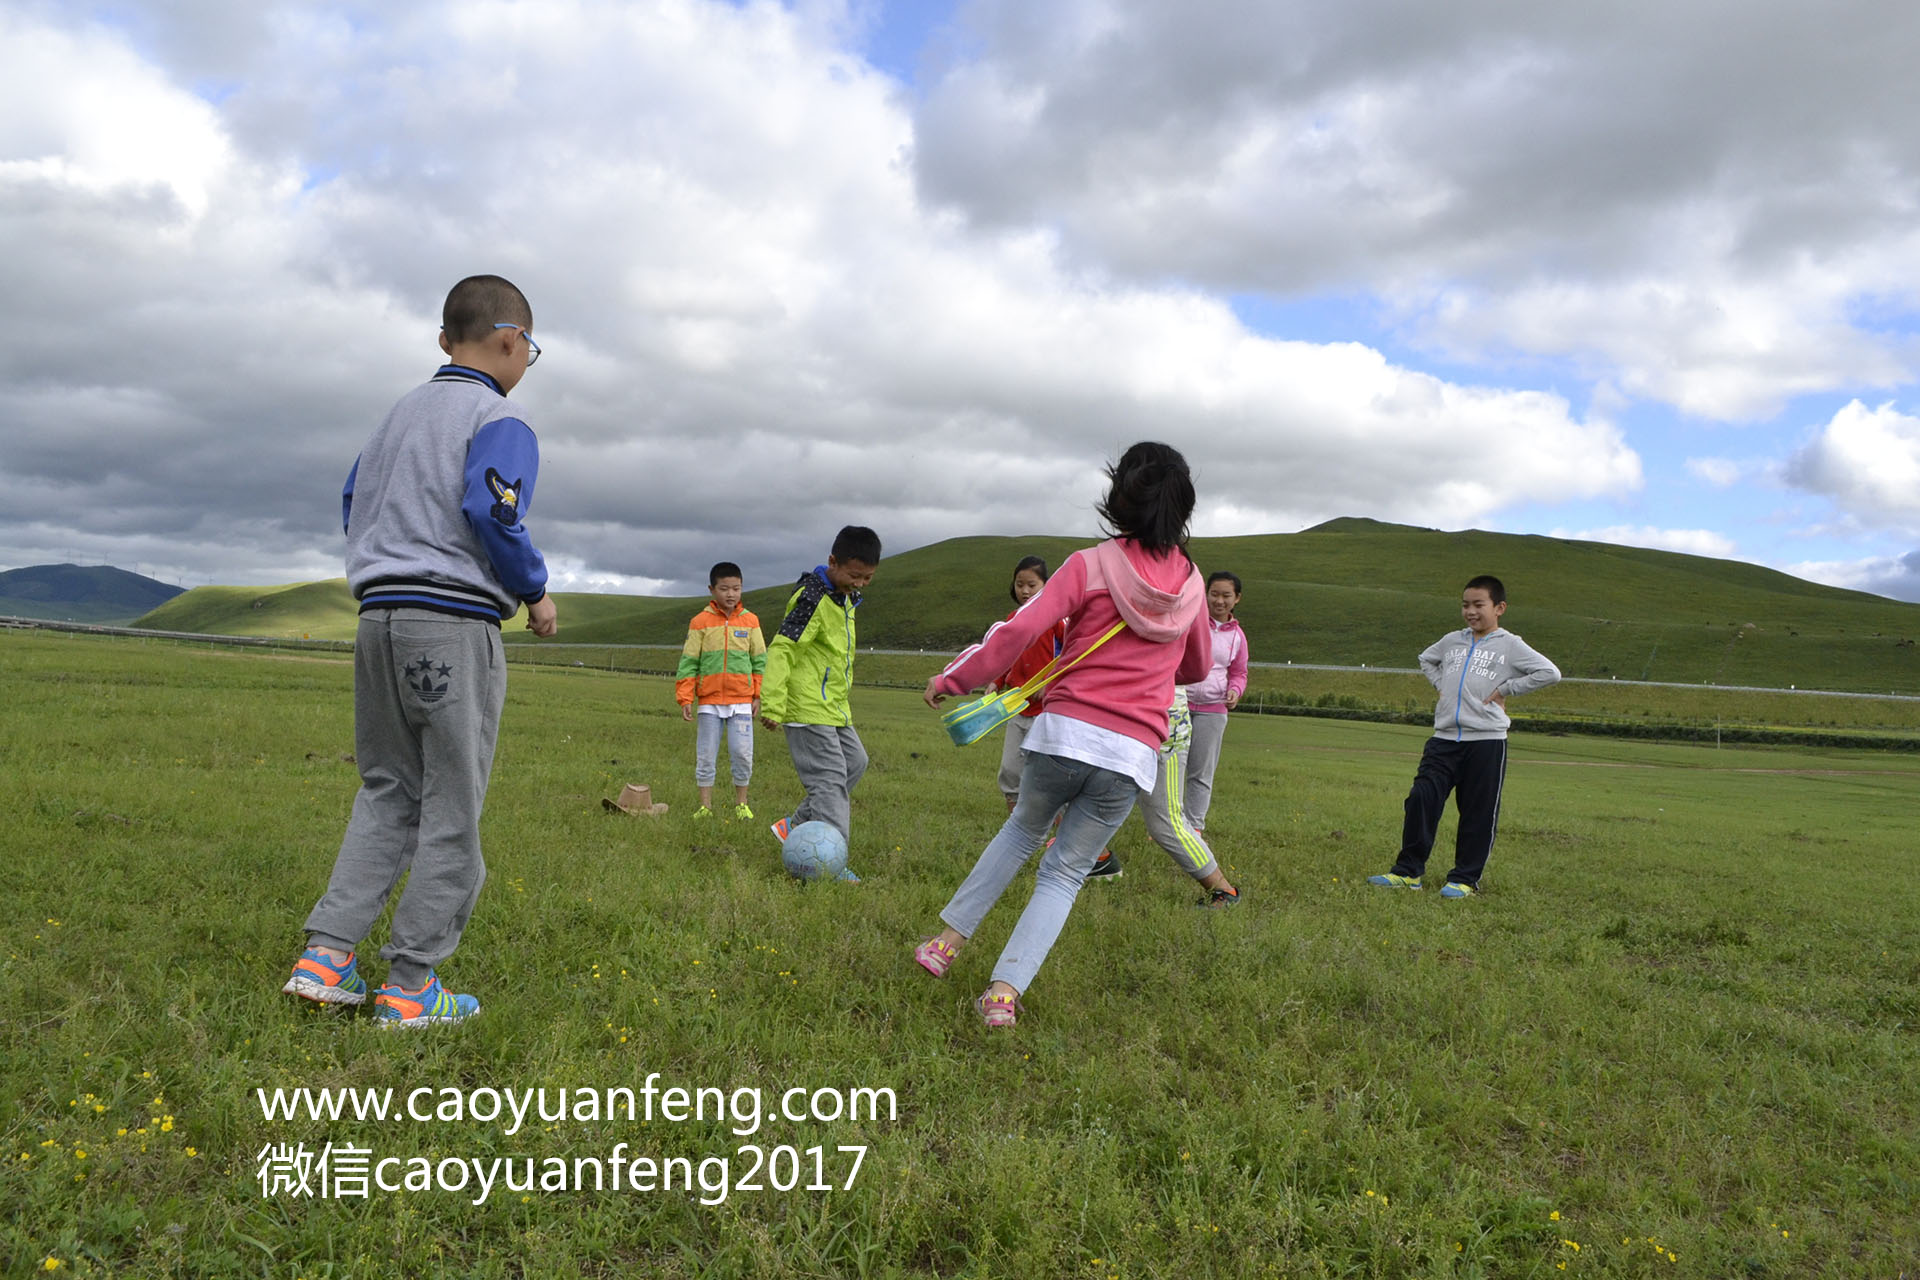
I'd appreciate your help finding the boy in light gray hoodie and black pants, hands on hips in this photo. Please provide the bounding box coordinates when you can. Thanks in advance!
[1367,574,1559,898]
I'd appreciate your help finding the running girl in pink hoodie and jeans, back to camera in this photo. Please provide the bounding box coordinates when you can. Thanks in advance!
[914,441,1212,1027]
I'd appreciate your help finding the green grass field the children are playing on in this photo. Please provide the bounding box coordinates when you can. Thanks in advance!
[0,633,1920,1280]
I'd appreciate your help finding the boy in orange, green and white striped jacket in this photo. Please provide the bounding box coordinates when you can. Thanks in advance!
[674,560,766,819]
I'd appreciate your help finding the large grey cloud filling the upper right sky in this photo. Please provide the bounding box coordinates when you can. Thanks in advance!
[914,0,1920,420]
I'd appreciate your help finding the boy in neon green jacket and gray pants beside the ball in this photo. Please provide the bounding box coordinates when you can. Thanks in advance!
[760,524,879,883]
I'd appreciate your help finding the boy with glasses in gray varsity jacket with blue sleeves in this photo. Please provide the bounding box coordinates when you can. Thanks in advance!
[282,276,557,1027]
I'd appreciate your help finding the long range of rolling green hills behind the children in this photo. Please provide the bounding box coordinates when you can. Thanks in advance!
[140,520,1920,693]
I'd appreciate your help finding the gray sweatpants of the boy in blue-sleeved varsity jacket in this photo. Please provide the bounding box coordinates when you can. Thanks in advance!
[307,608,507,990]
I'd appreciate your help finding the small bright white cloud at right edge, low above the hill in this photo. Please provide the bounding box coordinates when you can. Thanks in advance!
[1784,401,1920,530]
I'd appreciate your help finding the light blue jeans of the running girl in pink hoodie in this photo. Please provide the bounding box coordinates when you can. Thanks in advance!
[941,750,1140,992]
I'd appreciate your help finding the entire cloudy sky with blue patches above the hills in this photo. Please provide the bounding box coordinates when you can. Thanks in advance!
[0,0,1920,599]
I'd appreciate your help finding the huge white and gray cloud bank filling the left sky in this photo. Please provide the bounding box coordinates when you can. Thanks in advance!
[0,0,1642,591]
